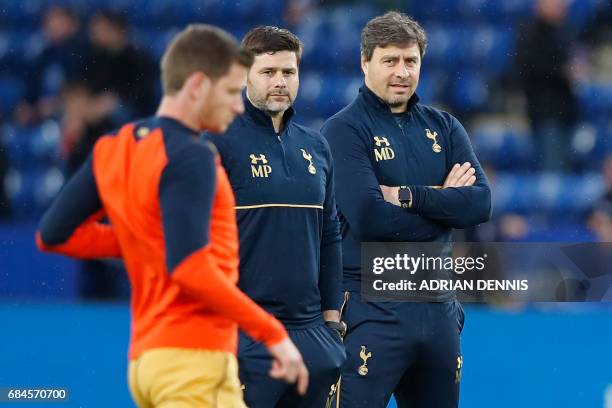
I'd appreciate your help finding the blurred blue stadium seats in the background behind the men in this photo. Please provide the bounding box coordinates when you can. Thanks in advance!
[0,0,612,239]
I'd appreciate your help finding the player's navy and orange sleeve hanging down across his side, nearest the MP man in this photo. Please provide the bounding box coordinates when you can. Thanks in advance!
[159,144,287,346]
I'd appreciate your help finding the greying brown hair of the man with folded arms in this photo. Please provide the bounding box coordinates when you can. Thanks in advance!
[361,11,427,61]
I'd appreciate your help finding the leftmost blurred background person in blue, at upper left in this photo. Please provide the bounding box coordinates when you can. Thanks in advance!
[15,5,87,124]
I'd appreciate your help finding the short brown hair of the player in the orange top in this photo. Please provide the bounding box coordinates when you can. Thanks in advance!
[161,24,253,95]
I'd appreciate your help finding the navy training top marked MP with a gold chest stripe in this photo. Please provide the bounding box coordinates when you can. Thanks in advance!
[204,96,342,328]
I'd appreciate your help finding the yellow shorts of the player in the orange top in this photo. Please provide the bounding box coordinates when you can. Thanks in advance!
[128,348,246,408]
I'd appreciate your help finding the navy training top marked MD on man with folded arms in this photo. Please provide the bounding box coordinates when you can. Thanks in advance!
[321,85,491,301]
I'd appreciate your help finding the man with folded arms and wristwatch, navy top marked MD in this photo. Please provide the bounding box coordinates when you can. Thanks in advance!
[322,12,491,408]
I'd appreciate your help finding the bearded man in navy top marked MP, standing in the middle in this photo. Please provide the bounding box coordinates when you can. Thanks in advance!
[205,26,345,408]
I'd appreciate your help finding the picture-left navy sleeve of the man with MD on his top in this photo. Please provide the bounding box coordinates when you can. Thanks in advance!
[321,119,446,241]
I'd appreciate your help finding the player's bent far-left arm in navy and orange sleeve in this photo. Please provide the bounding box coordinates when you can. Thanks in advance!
[36,156,121,259]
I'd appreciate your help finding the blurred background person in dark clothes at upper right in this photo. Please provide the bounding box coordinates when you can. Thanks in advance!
[515,0,578,171]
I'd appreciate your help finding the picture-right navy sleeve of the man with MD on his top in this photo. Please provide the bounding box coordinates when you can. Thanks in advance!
[408,116,491,228]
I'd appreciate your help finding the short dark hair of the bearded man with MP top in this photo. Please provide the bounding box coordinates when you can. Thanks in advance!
[242,26,304,65]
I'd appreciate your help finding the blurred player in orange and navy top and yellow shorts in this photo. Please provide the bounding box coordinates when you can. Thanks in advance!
[37,25,308,407]
